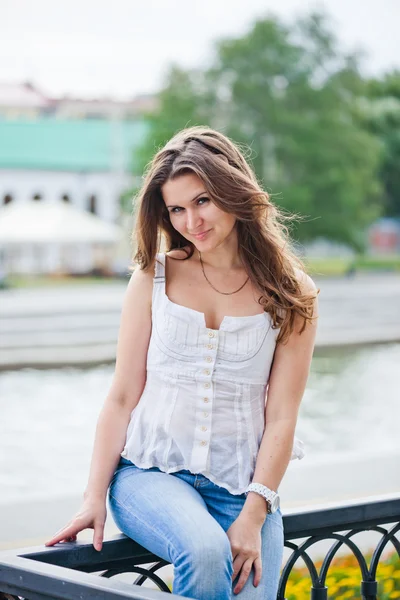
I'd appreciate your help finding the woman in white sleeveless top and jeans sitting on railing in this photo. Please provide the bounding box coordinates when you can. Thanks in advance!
[46,127,318,600]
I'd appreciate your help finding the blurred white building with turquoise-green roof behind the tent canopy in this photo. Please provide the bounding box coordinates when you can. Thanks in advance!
[0,96,146,272]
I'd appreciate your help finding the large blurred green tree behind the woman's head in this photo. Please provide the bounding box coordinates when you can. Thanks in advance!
[131,9,383,251]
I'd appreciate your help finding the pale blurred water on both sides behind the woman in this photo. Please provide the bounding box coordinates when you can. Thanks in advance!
[0,344,400,504]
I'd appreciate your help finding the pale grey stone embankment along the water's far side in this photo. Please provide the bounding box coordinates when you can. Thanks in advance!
[0,274,400,369]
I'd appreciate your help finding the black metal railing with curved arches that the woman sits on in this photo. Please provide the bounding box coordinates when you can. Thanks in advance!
[0,498,400,600]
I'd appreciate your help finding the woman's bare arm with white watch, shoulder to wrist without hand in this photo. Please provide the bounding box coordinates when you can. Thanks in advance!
[243,274,318,523]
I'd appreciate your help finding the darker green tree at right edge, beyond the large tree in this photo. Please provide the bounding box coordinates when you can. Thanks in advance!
[360,71,400,217]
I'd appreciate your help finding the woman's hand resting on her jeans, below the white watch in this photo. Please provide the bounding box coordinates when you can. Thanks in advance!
[226,515,262,594]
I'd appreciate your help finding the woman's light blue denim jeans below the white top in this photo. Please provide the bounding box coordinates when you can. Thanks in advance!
[109,457,283,600]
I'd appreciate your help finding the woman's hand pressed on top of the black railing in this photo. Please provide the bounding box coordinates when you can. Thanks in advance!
[45,499,107,552]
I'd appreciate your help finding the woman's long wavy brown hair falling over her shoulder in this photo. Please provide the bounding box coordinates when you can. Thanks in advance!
[132,126,319,342]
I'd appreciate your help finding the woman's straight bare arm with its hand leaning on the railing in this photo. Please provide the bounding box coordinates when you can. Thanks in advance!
[46,269,153,550]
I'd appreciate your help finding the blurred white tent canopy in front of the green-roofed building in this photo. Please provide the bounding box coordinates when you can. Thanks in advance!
[0,200,122,246]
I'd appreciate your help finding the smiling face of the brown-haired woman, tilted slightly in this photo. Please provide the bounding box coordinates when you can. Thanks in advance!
[161,173,236,252]
